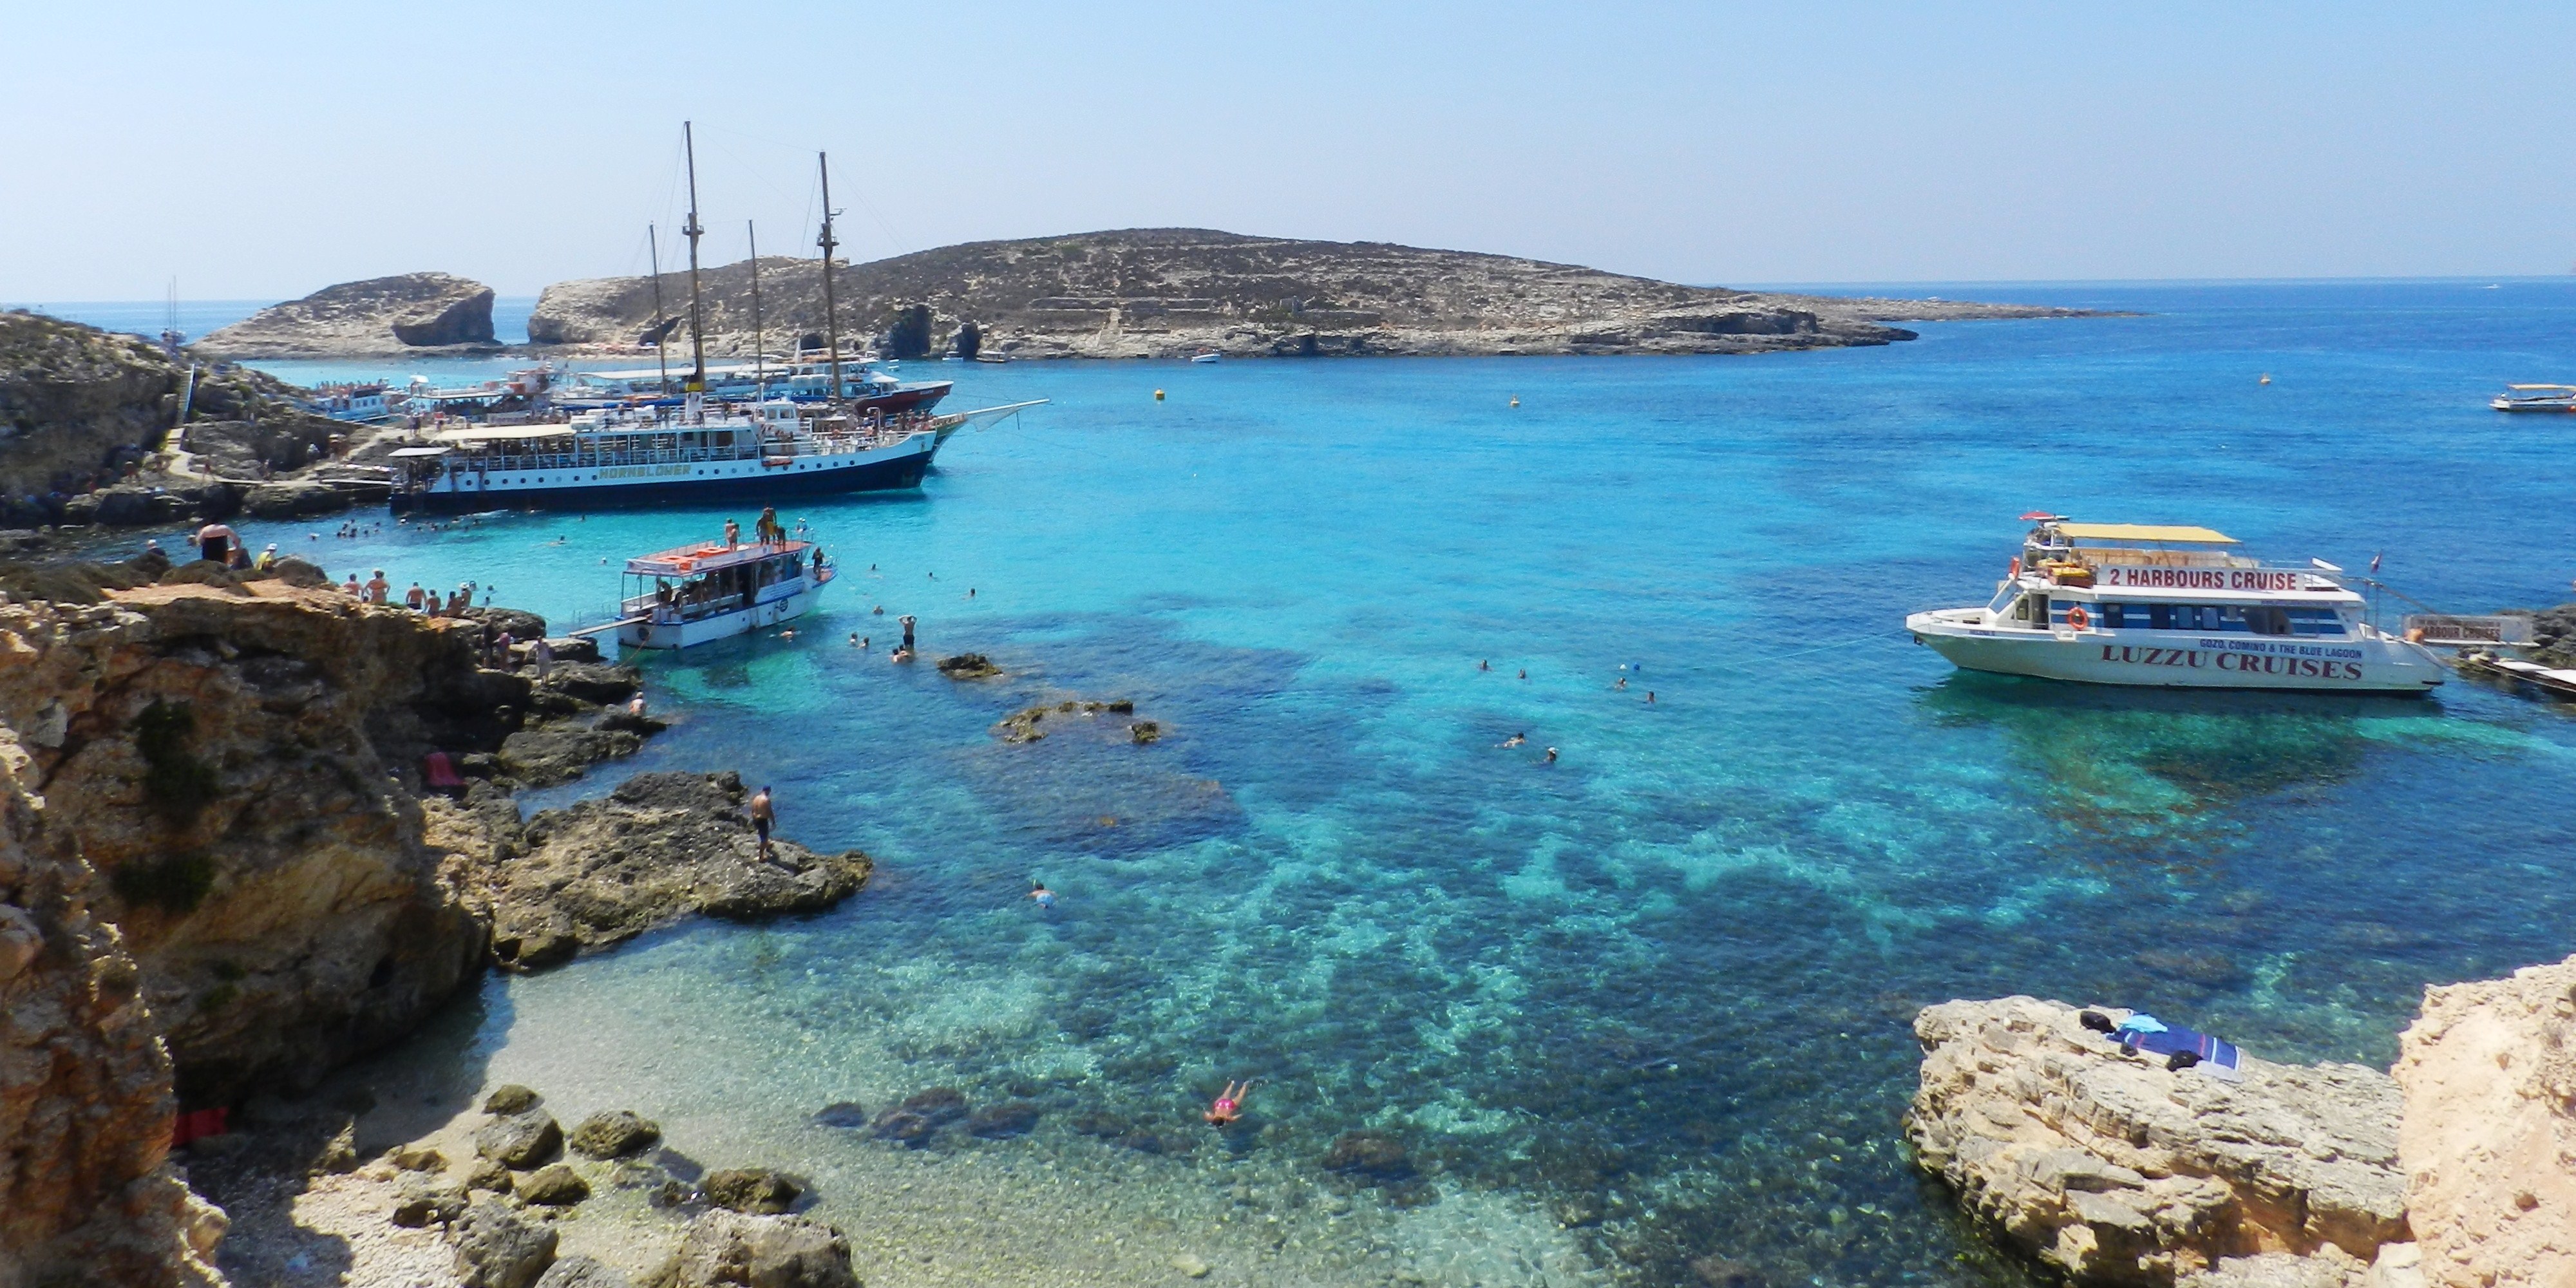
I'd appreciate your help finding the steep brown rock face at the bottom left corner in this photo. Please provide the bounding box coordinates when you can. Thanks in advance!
[0,729,224,1288]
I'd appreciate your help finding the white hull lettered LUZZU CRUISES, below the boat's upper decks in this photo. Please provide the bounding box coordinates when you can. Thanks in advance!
[1906,608,2447,693]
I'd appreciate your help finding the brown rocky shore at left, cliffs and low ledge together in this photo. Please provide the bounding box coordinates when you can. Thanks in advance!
[0,577,868,1283]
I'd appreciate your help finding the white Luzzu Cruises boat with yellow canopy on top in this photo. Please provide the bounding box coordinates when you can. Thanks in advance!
[1906,515,2445,693]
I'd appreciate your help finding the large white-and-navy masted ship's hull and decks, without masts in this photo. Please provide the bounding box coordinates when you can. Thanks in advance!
[392,394,1046,515]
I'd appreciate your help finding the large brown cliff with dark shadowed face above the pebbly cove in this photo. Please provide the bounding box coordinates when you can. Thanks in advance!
[0,582,528,1103]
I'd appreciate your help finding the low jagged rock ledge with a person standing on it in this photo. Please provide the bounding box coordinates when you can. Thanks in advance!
[466,773,871,971]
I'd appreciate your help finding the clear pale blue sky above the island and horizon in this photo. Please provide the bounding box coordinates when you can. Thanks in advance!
[0,0,2576,301]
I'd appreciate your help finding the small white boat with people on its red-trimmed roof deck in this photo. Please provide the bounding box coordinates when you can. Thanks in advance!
[618,541,832,649]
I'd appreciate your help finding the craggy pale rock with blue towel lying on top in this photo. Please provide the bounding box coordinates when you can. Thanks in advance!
[1906,997,2406,1285]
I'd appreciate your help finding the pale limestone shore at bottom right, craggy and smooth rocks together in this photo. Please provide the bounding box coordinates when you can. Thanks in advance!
[1906,958,2576,1288]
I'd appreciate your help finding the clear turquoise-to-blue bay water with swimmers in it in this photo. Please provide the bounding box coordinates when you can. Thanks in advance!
[206,281,2576,1283]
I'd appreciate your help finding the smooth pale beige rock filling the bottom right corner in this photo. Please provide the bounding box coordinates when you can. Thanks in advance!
[2396,958,2576,1288]
